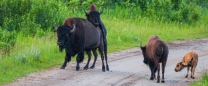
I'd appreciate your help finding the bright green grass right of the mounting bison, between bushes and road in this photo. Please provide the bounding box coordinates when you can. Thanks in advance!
[103,18,208,51]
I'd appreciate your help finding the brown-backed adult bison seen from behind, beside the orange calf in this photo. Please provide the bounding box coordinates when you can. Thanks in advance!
[140,36,169,83]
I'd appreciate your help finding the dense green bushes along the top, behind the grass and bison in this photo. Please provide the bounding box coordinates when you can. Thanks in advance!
[0,0,208,52]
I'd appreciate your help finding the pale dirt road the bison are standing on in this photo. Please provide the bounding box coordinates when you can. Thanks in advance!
[6,38,208,86]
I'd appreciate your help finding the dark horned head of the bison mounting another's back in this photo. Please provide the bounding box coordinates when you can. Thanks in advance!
[84,9,103,27]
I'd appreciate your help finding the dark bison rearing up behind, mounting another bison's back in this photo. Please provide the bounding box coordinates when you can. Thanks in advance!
[84,4,109,71]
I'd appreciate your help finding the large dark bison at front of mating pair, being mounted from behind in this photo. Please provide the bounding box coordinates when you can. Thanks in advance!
[55,18,105,71]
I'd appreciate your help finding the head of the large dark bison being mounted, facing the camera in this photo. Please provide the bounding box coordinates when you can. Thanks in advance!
[54,24,76,51]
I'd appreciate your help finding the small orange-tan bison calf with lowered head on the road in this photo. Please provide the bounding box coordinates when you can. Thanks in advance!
[175,51,198,79]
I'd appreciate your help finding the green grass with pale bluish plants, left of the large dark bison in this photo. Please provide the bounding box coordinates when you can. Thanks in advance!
[0,33,64,85]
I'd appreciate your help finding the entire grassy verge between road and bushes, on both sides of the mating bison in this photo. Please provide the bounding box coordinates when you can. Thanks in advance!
[0,18,208,85]
